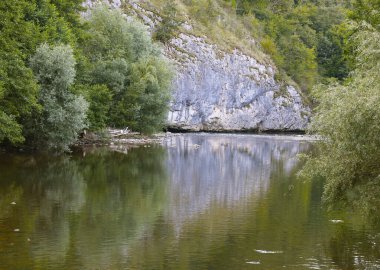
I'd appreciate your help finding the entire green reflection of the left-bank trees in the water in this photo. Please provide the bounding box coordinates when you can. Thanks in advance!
[0,148,166,269]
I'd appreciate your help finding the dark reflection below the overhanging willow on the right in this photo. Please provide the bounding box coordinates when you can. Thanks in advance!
[328,180,380,269]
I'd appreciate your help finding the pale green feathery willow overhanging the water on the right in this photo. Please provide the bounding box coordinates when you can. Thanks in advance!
[303,24,380,204]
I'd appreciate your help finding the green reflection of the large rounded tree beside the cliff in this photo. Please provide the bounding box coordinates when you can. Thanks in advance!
[70,148,166,269]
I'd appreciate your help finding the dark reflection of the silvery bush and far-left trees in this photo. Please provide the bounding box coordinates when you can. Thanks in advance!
[0,156,85,269]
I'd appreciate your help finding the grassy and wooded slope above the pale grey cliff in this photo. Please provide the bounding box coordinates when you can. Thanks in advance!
[139,0,352,93]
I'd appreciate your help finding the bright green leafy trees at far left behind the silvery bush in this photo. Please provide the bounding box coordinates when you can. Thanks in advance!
[0,0,81,148]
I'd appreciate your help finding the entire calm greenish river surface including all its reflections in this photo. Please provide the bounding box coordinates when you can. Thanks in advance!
[0,134,380,269]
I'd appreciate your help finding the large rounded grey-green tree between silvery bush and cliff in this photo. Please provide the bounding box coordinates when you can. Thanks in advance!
[84,7,171,133]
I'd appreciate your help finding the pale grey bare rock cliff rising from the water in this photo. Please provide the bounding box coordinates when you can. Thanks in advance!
[166,34,310,131]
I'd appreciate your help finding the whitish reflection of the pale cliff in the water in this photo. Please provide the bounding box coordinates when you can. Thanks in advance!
[167,134,309,229]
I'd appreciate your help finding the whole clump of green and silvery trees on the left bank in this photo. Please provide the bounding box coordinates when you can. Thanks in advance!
[0,0,172,152]
